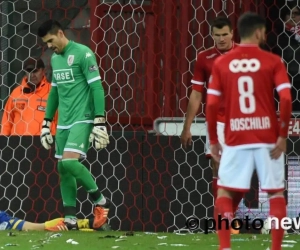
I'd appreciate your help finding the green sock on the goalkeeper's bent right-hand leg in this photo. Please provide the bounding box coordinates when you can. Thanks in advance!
[63,159,101,194]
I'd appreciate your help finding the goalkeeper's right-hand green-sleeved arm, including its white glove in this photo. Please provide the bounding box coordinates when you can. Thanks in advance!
[80,49,109,149]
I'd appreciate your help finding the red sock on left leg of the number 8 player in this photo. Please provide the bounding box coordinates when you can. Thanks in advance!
[216,197,233,250]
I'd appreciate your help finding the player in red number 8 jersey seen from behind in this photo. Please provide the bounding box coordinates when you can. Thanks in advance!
[206,13,292,250]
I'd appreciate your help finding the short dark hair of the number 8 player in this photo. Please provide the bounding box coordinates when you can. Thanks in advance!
[237,12,266,39]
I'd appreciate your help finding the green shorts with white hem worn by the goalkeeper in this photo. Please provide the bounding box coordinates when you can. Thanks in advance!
[55,123,93,159]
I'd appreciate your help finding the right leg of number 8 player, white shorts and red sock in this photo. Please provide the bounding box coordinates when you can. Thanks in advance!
[255,148,287,250]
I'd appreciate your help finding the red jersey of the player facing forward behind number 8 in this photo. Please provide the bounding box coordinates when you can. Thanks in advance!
[191,43,237,122]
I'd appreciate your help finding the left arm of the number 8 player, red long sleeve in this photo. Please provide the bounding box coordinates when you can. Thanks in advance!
[205,64,222,162]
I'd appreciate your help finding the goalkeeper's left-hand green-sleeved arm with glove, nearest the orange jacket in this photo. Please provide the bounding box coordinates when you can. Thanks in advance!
[40,65,59,149]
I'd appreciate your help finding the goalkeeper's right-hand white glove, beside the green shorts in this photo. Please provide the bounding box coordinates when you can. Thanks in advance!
[90,117,109,149]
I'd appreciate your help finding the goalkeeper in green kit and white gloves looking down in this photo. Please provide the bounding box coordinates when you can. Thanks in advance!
[38,20,110,229]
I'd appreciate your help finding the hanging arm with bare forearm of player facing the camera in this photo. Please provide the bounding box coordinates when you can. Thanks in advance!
[180,54,205,148]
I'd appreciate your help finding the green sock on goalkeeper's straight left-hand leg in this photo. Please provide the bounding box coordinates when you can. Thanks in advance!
[57,161,77,218]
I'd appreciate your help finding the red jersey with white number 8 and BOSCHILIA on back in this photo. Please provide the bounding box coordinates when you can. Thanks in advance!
[207,45,291,147]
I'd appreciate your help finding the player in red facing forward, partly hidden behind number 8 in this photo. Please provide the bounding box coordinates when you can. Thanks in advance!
[181,16,243,233]
